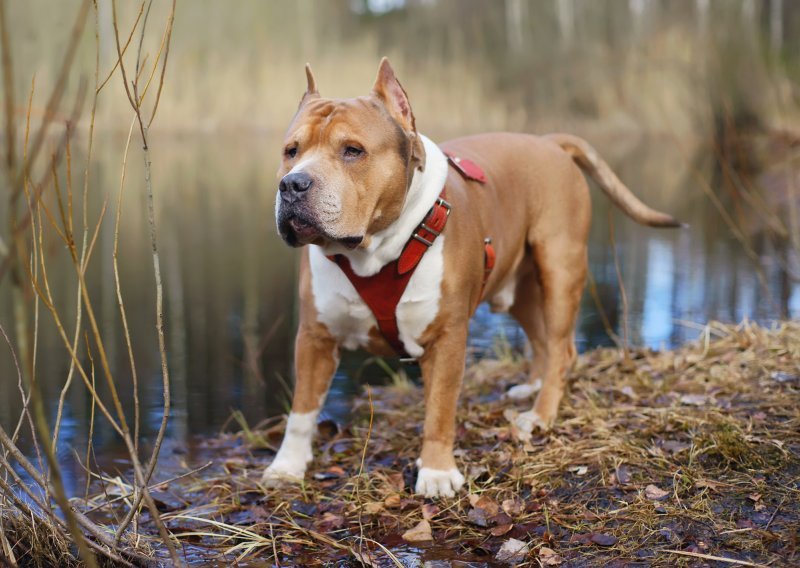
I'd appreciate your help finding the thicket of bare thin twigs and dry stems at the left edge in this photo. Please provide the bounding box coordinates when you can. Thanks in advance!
[0,0,182,566]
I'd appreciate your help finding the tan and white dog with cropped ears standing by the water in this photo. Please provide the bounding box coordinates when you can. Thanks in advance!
[264,58,678,497]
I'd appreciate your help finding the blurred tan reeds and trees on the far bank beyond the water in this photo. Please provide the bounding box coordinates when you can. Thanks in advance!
[9,0,800,141]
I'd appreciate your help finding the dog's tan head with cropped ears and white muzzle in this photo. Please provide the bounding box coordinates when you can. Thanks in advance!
[275,58,425,248]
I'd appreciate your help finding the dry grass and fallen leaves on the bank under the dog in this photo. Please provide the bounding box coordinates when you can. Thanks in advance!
[64,323,800,566]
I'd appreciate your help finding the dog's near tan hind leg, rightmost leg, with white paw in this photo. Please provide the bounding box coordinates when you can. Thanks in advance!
[516,233,587,433]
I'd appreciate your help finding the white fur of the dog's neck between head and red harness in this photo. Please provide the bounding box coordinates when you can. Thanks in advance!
[318,135,447,276]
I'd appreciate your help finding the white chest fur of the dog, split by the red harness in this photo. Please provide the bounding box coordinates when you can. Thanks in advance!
[309,241,444,357]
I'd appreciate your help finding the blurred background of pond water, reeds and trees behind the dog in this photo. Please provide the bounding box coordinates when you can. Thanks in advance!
[0,0,800,474]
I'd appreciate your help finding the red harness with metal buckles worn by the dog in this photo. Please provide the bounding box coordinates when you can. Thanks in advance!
[328,152,495,358]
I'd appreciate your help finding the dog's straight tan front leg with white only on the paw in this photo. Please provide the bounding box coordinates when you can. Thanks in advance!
[416,324,467,497]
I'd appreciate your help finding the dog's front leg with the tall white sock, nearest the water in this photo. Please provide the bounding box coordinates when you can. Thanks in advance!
[262,325,339,485]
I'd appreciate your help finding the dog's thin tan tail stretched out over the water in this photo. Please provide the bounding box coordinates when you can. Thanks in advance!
[544,133,683,227]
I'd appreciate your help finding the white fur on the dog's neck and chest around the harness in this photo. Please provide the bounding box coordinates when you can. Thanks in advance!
[309,136,447,357]
